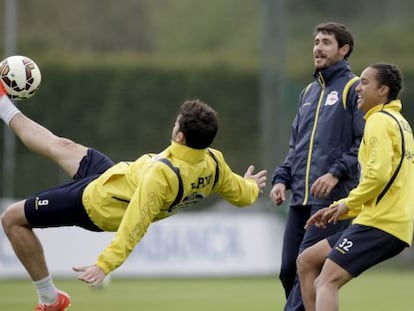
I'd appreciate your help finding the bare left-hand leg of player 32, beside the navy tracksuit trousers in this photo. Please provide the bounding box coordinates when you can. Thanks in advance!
[297,240,331,311]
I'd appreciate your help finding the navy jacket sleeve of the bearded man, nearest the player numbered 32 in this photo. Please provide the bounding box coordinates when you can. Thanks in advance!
[329,85,365,179]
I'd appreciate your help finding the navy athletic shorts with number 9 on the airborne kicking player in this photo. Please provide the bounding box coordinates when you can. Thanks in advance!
[24,149,114,231]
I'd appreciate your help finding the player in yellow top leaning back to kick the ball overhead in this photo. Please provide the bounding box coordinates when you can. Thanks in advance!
[0,82,266,311]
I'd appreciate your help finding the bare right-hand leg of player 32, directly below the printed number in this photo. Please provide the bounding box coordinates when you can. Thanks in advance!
[315,258,353,311]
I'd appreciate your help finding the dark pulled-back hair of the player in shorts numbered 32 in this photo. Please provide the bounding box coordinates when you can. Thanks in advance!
[369,63,403,101]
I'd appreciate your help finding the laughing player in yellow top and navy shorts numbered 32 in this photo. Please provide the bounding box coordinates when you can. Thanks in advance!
[298,64,414,311]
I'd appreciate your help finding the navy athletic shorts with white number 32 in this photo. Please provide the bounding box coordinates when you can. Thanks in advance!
[327,225,408,277]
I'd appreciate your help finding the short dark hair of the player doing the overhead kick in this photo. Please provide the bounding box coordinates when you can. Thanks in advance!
[178,99,218,149]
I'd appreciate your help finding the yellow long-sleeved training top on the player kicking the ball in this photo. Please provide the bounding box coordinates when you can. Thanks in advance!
[82,142,259,273]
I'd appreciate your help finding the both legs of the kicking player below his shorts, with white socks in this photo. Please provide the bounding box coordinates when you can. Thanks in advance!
[0,82,74,310]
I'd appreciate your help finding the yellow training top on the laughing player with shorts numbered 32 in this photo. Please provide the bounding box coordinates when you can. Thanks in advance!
[344,100,414,245]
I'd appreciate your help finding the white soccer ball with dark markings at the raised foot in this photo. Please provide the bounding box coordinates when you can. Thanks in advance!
[0,55,42,100]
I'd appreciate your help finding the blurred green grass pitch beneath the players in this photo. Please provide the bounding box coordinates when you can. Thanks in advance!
[0,269,414,311]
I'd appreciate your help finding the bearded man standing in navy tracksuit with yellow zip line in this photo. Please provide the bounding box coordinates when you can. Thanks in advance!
[270,23,364,310]
